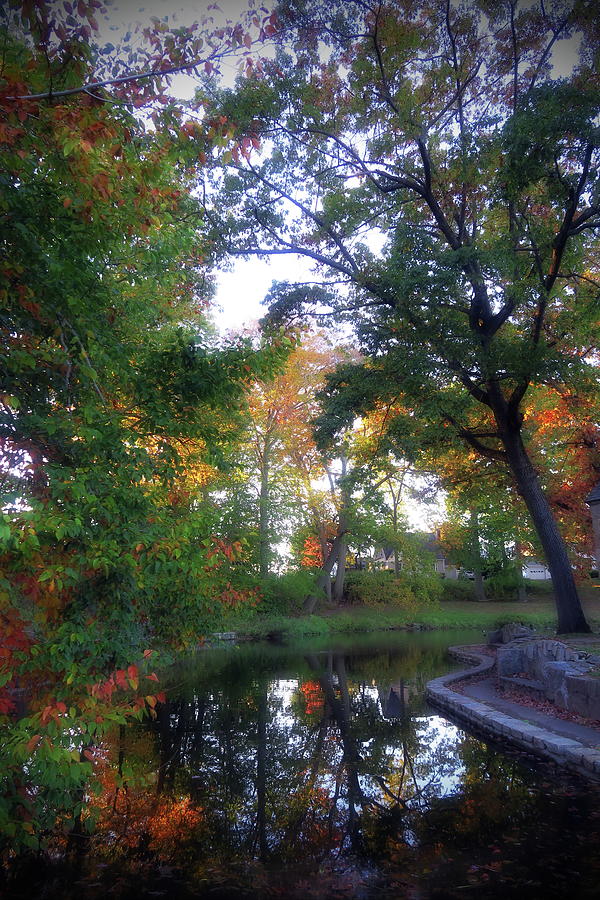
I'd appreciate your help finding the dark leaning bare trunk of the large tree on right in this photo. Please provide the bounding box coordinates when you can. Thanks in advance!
[500,423,590,634]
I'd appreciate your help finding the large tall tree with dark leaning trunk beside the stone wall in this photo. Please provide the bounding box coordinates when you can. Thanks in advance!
[199,0,600,632]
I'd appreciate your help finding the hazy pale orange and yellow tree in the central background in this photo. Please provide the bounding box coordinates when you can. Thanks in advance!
[209,328,347,578]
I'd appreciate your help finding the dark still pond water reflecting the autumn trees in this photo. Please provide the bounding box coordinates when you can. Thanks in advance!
[11,632,600,900]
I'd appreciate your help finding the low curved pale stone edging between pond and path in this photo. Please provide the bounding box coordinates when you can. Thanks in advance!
[426,647,600,781]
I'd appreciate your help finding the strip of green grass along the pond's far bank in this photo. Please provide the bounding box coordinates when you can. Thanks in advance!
[224,597,600,640]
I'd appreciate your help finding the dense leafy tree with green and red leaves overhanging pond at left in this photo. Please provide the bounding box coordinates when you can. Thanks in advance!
[0,10,289,849]
